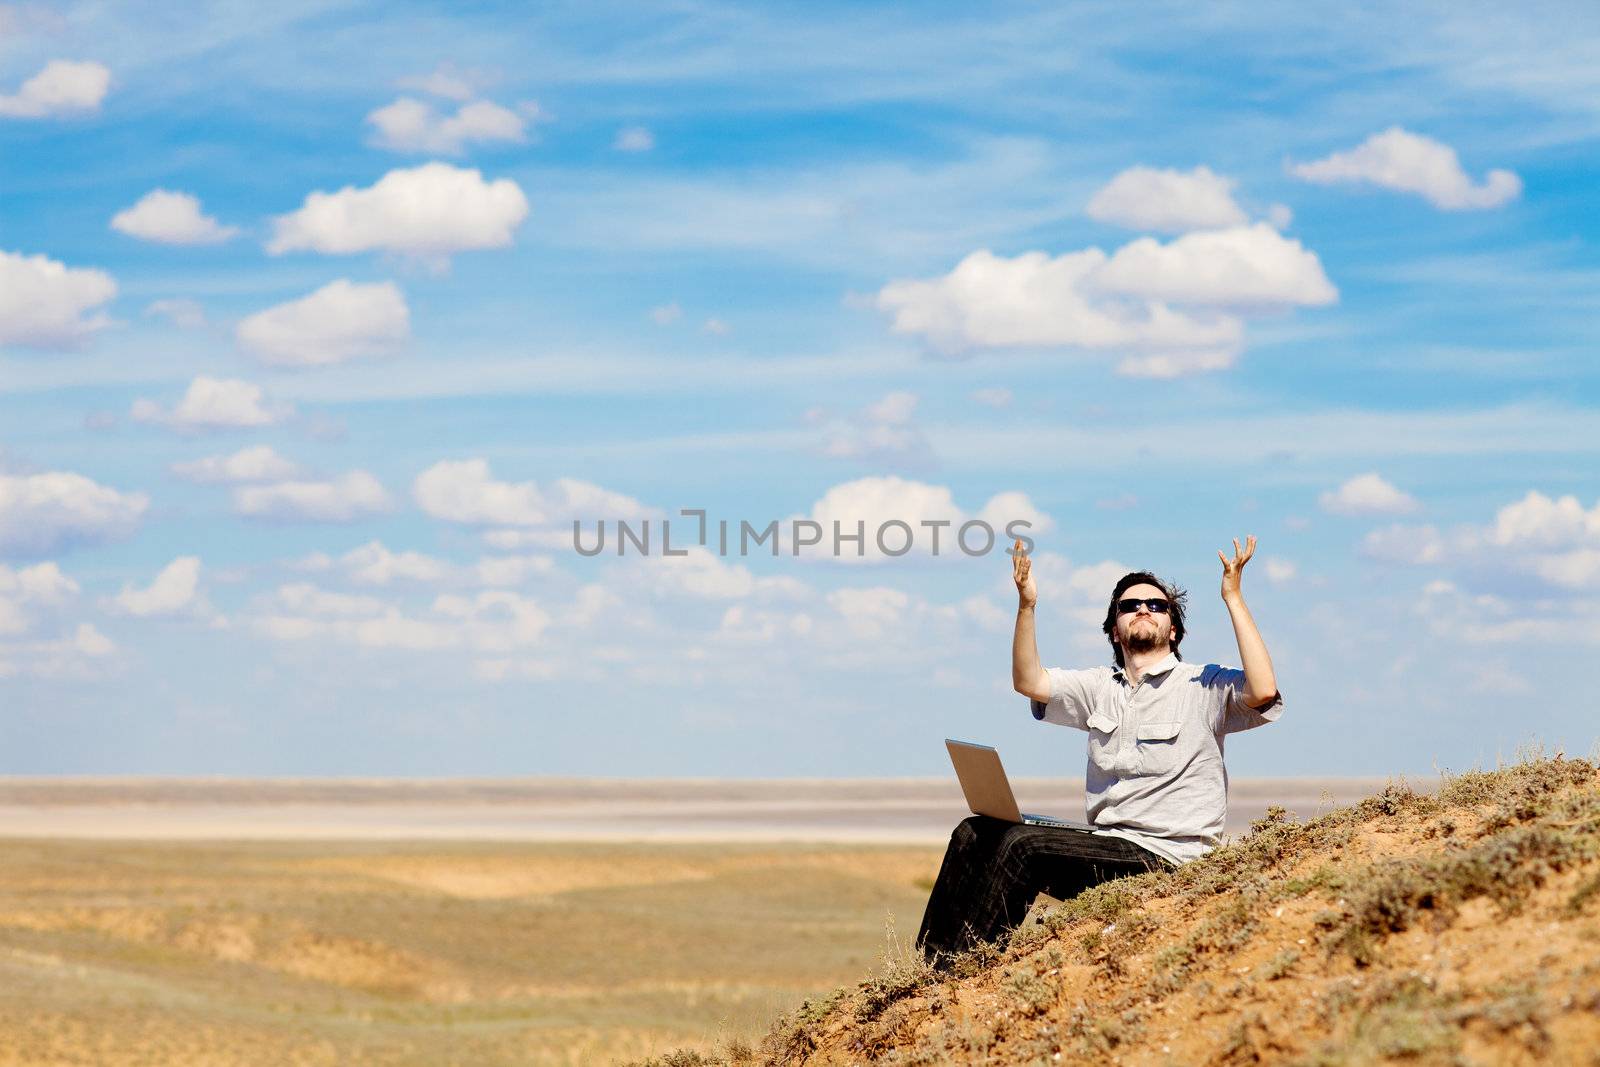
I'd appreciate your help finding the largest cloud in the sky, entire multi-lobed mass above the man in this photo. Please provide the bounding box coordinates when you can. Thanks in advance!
[877,222,1338,378]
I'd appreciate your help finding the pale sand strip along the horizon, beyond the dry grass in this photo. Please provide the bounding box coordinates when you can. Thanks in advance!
[0,777,1401,845]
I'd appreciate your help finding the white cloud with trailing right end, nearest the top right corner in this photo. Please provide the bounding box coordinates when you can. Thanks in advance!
[1288,126,1522,211]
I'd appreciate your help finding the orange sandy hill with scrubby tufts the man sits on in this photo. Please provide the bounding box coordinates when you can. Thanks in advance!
[633,757,1600,1067]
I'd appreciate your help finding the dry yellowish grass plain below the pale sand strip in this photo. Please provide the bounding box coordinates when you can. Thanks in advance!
[0,840,939,1067]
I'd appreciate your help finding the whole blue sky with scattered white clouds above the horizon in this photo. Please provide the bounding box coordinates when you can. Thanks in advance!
[0,0,1600,777]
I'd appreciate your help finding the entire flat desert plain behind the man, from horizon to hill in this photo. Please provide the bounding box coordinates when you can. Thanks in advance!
[0,777,1382,1067]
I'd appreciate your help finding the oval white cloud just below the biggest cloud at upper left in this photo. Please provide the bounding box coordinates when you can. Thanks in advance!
[237,278,411,366]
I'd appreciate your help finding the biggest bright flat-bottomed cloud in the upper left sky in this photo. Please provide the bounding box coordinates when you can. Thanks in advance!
[267,162,528,261]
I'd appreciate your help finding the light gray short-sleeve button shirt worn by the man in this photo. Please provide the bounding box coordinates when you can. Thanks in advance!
[1030,654,1283,864]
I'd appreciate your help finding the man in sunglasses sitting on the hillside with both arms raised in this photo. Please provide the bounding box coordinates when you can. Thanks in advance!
[917,536,1283,963]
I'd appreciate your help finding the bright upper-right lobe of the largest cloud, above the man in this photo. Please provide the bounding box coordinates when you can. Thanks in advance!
[1090,222,1339,307]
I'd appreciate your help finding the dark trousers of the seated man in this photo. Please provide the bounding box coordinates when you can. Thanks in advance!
[917,816,1171,963]
